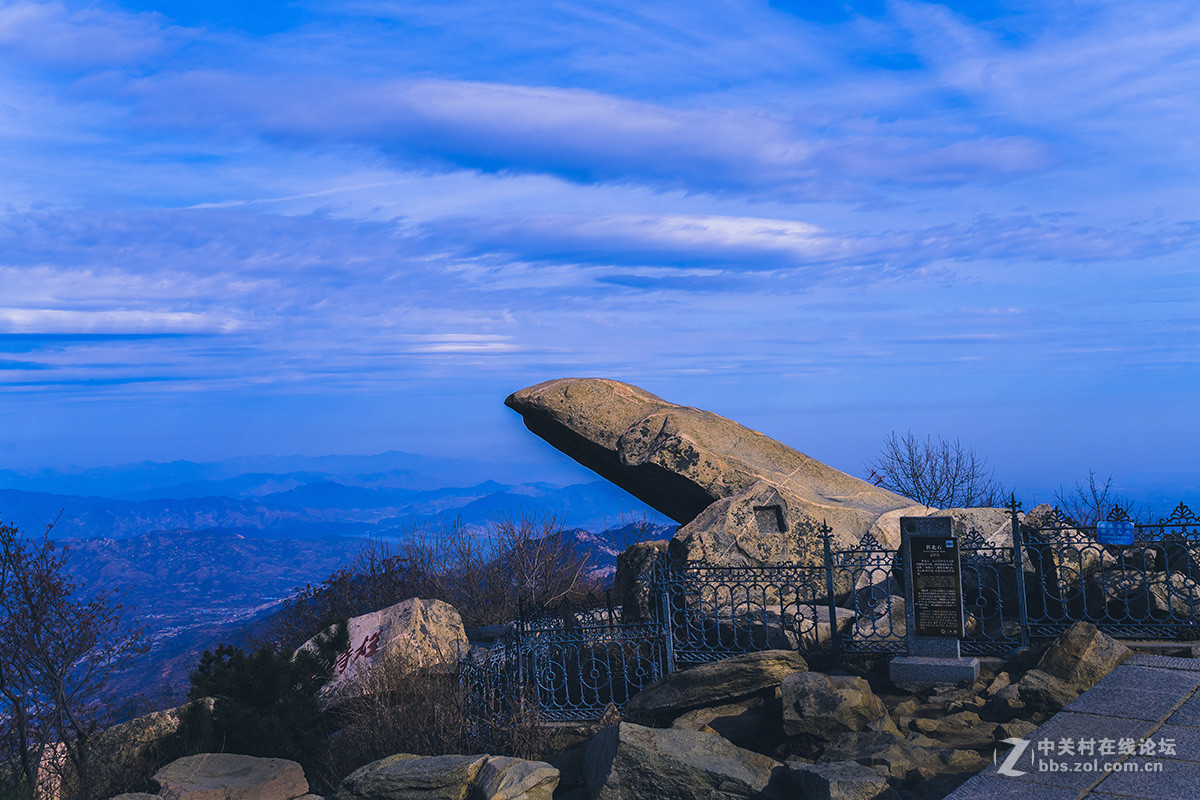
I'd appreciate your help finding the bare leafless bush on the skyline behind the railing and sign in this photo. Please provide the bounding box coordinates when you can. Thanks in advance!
[866,431,1004,509]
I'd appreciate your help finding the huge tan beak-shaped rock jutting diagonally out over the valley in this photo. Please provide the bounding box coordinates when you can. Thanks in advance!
[504,378,913,565]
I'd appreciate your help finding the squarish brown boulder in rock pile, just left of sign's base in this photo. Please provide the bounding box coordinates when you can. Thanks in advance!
[780,672,896,741]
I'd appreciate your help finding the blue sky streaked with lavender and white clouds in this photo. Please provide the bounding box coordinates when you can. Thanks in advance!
[0,0,1200,499]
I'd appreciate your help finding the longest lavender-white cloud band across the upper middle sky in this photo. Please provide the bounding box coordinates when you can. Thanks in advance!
[129,71,1048,200]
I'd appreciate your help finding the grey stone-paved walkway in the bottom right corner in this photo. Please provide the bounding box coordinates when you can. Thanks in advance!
[946,655,1200,800]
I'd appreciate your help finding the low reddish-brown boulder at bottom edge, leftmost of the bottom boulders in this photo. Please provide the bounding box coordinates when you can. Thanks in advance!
[151,753,308,800]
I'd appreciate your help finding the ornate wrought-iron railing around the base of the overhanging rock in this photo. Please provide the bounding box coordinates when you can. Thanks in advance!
[462,499,1200,720]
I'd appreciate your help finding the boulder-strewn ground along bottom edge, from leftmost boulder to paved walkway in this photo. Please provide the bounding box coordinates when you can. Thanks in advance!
[103,622,1152,800]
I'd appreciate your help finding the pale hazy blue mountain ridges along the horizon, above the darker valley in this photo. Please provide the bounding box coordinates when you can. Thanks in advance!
[0,453,668,539]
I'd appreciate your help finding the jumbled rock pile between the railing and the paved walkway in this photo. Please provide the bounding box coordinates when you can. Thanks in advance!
[540,622,1130,800]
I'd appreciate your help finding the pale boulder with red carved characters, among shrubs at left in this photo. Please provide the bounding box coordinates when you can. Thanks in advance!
[298,597,470,693]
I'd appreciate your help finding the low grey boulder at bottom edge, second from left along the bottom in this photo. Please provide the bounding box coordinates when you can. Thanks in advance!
[334,753,488,800]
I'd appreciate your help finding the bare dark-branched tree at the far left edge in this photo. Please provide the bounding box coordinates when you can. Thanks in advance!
[0,525,146,798]
